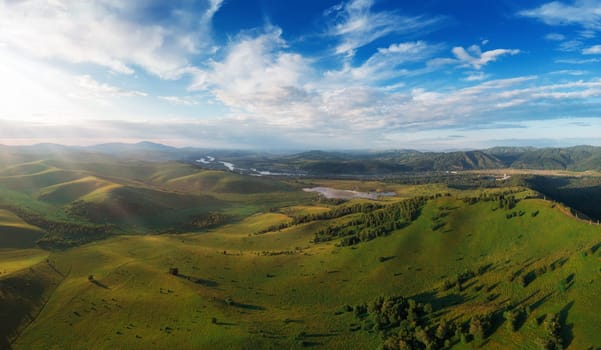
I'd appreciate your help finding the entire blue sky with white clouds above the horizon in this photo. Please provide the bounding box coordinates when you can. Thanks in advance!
[0,0,601,150]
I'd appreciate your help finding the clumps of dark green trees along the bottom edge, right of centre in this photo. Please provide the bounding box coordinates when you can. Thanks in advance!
[352,296,552,350]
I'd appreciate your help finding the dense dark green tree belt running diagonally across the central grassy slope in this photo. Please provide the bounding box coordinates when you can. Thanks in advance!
[313,195,426,246]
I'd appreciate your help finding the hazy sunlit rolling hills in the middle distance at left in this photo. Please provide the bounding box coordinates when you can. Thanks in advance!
[0,153,314,248]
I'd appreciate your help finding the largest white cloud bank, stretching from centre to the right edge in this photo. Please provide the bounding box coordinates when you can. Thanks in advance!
[184,18,598,137]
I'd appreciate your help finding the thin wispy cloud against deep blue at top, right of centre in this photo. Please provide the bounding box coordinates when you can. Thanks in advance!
[326,0,439,56]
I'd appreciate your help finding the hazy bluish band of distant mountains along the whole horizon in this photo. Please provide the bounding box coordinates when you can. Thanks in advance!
[0,142,601,176]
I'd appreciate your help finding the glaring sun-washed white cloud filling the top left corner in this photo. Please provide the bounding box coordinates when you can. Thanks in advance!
[0,0,221,79]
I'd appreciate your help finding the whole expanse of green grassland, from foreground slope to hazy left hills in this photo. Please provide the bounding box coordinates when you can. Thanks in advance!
[0,154,601,349]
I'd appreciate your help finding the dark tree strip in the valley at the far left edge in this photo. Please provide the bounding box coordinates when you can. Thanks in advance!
[2,205,116,249]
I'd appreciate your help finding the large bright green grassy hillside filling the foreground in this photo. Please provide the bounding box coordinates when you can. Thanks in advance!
[7,192,601,349]
